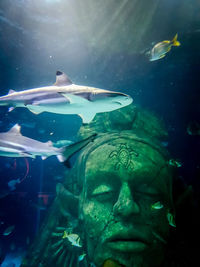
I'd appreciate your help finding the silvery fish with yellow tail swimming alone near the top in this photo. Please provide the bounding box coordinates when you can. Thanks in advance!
[149,34,181,61]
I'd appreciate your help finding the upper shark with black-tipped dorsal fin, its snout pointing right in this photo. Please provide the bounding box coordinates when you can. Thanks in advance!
[0,71,133,123]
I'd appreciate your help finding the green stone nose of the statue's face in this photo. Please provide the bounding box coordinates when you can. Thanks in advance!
[113,183,140,217]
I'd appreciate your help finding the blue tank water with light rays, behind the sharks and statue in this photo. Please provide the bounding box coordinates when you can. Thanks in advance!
[0,0,200,266]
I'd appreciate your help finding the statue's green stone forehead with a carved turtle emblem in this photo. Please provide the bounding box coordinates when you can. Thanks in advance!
[86,138,166,173]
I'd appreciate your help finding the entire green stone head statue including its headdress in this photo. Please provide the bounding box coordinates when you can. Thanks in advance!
[19,107,175,267]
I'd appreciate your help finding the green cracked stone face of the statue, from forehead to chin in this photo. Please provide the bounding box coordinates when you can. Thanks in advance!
[81,139,170,267]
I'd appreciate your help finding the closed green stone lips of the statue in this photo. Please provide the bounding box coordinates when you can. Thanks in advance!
[106,231,149,253]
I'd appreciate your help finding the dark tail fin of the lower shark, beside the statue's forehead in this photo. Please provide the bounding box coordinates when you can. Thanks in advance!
[57,133,97,168]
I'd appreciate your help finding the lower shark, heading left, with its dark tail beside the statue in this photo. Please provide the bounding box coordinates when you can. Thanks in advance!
[0,124,96,166]
